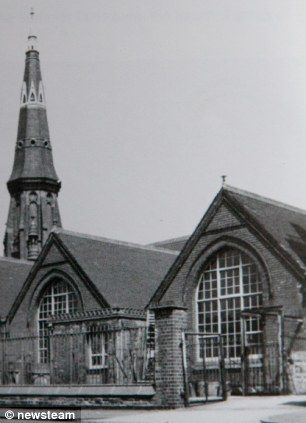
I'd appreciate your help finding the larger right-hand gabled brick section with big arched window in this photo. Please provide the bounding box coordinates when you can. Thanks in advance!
[151,186,306,408]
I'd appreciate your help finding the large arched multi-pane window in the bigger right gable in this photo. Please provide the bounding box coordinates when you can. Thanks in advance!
[196,248,262,358]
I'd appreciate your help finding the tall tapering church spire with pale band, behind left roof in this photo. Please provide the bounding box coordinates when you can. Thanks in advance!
[4,10,61,260]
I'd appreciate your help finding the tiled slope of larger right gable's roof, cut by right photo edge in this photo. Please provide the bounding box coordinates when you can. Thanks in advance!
[224,186,306,270]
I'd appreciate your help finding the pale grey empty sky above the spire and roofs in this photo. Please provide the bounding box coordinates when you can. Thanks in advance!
[0,0,306,247]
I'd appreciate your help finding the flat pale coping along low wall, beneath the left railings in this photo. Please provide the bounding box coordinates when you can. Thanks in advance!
[0,385,155,398]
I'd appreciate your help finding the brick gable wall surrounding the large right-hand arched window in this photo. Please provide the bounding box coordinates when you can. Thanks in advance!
[160,206,306,346]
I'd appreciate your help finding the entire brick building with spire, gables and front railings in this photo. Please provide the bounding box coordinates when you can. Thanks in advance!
[0,22,306,407]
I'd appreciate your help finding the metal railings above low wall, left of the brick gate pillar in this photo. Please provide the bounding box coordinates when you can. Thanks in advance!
[0,325,155,386]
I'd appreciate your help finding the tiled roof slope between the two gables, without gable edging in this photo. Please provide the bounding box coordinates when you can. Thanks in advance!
[53,229,177,308]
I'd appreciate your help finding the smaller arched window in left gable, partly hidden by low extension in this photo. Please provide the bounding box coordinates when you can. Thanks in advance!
[38,278,79,363]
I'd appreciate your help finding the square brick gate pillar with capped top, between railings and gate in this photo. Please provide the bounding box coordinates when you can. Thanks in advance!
[154,306,187,408]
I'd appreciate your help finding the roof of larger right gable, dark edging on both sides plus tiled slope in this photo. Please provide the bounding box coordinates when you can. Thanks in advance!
[150,185,306,305]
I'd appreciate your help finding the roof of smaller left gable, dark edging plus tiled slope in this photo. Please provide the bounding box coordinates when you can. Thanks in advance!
[8,228,178,320]
